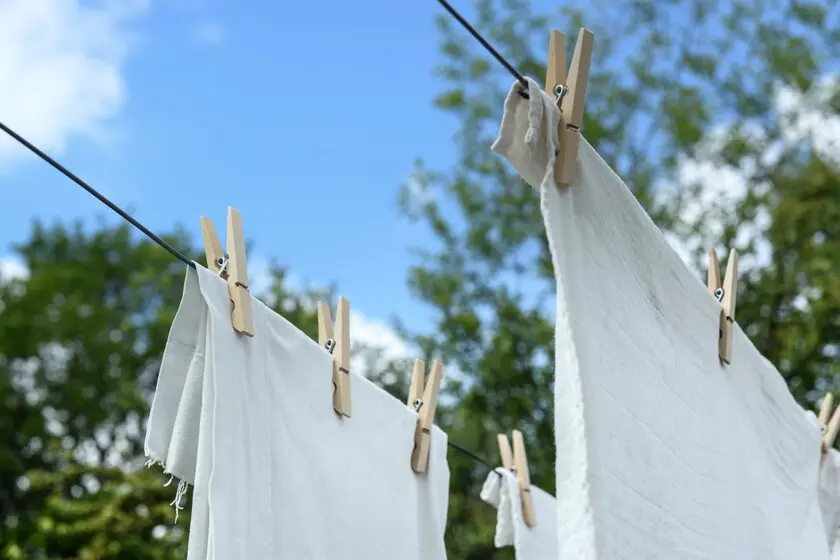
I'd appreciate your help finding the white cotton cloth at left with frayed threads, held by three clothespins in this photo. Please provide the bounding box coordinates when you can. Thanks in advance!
[146,266,449,560]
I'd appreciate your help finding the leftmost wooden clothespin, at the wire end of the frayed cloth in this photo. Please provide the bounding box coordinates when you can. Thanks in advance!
[201,206,254,336]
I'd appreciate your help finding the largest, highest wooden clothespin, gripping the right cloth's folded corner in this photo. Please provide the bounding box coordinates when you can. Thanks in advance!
[545,29,595,187]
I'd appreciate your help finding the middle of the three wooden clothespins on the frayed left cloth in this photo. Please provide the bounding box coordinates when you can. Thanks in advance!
[318,296,351,418]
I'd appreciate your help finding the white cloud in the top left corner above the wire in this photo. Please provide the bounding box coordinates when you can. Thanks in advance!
[0,0,148,166]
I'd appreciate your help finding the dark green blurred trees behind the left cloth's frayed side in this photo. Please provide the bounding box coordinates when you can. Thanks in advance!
[0,223,317,560]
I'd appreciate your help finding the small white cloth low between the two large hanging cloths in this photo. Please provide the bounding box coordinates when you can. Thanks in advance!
[480,467,557,560]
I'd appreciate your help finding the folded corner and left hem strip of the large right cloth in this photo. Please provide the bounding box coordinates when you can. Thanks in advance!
[492,79,598,560]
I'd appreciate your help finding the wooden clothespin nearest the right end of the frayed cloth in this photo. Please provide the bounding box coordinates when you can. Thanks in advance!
[406,360,443,473]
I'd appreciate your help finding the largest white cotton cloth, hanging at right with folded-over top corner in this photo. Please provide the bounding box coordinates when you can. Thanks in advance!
[493,77,828,560]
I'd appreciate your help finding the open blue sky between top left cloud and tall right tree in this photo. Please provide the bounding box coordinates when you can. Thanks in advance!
[0,0,486,336]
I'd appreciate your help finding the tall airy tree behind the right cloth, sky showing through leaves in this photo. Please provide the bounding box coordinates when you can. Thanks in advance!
[401,0,840,559]
